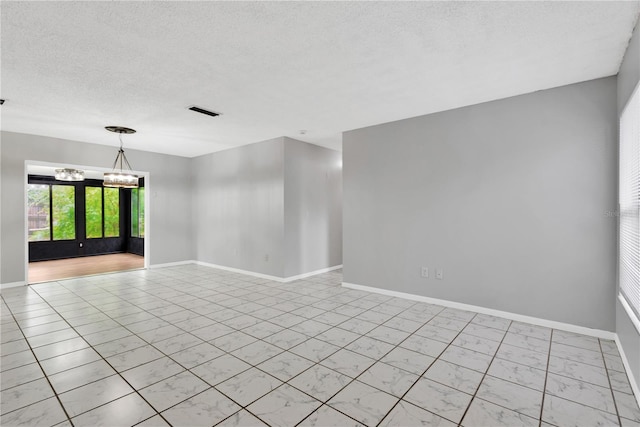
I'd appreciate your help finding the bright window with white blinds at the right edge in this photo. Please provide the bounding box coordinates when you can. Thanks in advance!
[619,86,640,320]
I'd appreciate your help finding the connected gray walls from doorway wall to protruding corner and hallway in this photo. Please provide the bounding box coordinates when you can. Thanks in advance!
[0,132,342,283]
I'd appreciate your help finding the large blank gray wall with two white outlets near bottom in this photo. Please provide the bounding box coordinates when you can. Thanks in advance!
[343,77,617,331]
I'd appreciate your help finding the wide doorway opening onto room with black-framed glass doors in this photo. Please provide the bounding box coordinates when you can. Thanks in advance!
[25,163,149,284]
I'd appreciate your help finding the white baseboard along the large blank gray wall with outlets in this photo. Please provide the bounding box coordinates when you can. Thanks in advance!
[342,282,616,341]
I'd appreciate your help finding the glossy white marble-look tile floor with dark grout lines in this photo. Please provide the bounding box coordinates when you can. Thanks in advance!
[0,265,640,427]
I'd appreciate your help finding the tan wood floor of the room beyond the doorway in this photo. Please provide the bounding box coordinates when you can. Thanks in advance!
[29,254,144,283]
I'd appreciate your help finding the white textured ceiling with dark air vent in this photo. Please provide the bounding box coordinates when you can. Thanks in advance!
[0,1,640,157]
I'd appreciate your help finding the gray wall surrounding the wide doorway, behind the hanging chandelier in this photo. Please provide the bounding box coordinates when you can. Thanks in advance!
[0,132,193,283]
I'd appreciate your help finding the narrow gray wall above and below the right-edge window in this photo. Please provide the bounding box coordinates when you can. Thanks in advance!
[616,20,640,392]
